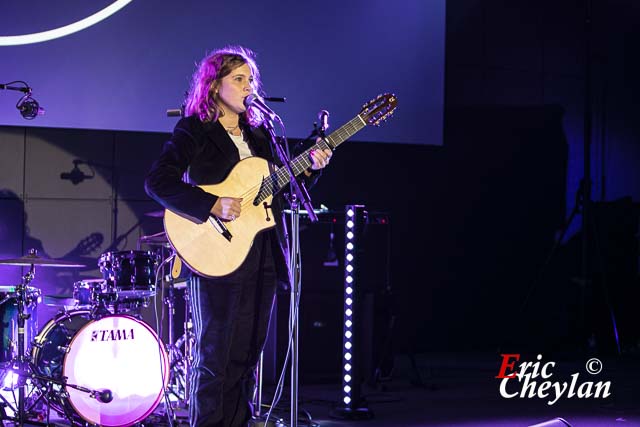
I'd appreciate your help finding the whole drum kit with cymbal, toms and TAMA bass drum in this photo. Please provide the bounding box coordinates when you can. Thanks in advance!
[0,235,193,427]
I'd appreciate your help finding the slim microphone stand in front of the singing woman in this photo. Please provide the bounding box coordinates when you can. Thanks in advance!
[265,114,318,427]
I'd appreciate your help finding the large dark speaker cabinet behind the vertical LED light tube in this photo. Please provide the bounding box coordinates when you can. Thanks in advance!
[263,213,393,383]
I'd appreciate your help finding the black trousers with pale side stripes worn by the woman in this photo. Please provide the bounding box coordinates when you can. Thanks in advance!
[189,234,276,427]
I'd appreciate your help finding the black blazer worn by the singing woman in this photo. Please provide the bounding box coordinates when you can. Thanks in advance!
[145,116,320,284]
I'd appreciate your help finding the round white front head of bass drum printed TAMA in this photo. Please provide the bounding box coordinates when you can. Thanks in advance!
[63,315,169,426]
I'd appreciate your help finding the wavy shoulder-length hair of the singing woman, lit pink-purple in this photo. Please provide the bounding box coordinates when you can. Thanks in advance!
[185,46,263,126]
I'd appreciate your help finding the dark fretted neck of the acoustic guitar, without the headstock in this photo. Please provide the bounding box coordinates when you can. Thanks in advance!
[253,114,367,206]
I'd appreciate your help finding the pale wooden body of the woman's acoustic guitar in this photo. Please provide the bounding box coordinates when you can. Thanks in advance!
[164,157,275,277]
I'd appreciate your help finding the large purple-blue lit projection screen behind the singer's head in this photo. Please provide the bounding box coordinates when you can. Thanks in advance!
[0,0,446,145]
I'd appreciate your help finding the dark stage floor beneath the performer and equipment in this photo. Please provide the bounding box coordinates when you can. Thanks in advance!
[5,353,640,427]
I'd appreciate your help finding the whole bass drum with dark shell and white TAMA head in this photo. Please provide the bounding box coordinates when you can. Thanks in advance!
[31,310,169,426]
